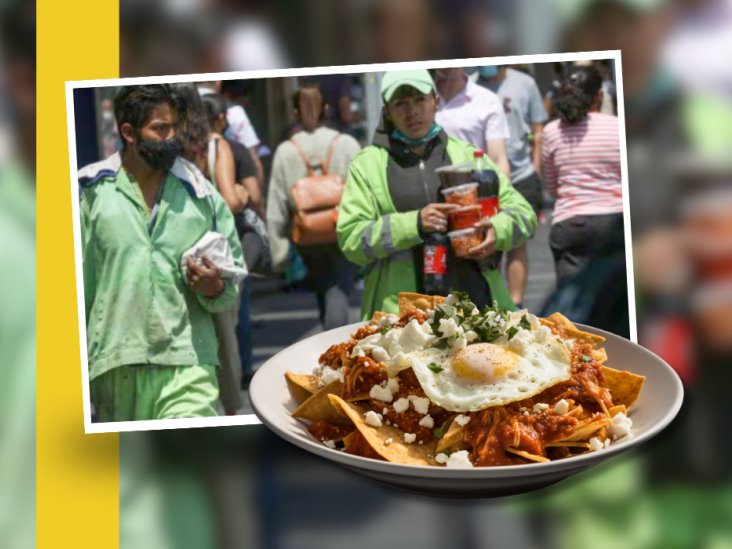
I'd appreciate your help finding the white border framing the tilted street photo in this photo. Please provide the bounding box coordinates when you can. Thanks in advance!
[66,50,638,434]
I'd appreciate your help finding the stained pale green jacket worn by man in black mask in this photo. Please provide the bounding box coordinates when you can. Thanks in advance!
[79,154,243,379]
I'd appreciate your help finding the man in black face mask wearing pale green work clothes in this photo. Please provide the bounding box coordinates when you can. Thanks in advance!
[78,85,243,422]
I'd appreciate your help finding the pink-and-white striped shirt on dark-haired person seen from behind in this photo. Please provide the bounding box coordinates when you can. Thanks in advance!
[542,112,623,223]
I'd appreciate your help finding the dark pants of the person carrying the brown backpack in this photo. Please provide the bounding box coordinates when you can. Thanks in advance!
[297,244,356,330]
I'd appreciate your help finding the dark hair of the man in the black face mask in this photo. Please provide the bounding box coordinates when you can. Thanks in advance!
[114,84,179,143]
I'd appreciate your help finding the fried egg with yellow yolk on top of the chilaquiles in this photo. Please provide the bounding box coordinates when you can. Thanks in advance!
[408,330,570,412]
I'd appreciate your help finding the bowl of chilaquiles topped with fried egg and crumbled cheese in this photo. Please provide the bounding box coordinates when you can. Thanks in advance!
[251,292,682,495]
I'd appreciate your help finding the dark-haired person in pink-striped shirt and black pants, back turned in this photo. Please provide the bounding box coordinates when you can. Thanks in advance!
[542,65,624,286]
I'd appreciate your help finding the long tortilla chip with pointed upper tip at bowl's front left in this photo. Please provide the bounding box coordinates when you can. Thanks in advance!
[328,394,438,465]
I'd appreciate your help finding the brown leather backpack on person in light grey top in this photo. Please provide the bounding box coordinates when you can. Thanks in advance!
[290,134,345,246]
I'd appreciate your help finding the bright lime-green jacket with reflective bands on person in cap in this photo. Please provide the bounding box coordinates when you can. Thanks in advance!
[337,137,536,319]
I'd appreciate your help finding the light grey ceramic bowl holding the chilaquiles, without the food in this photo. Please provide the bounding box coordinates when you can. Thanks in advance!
[249,324,683,497]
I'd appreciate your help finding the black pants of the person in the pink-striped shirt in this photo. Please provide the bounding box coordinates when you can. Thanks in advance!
[549,213,624,286]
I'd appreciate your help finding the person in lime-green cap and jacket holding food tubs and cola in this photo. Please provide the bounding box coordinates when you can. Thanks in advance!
[337,70,536,319]
